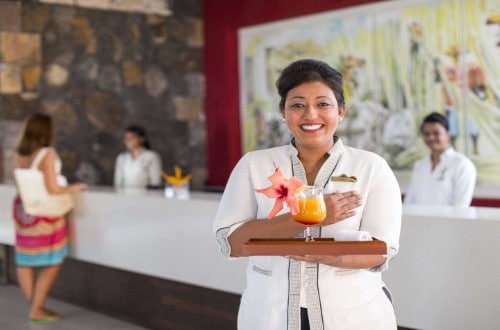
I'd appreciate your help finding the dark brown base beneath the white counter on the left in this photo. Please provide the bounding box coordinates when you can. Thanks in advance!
[3,247,240,330]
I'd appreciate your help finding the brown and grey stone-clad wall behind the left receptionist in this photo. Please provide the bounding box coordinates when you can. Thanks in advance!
[0,0,206,189]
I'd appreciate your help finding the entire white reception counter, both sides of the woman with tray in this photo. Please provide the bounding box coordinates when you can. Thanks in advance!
[0,185,500,330]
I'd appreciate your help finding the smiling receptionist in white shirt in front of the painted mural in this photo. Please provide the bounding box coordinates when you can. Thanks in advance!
[404,112,476,206]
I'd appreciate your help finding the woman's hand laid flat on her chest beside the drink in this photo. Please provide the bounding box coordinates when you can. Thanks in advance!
[320,191,362,226]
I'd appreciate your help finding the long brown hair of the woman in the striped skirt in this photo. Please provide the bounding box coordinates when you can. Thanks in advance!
[16,112,53,156]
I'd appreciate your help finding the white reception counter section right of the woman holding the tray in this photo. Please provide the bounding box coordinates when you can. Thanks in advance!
[383,205,500,330]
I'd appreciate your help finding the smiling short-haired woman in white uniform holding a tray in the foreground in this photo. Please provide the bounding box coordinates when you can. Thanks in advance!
[213,60,402,330]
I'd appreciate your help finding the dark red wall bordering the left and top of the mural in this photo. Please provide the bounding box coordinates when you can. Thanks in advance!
[203,0,377,187]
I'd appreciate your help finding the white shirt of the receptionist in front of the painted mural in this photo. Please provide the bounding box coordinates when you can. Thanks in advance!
[404,147,476,206]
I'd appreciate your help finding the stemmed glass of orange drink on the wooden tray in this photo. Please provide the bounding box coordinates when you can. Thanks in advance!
[292,186,326,242]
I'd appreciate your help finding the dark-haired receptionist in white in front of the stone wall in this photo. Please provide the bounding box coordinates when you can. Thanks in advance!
[114,126,162,188]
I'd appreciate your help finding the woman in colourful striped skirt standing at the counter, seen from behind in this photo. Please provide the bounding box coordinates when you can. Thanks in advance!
[13,113,87,323]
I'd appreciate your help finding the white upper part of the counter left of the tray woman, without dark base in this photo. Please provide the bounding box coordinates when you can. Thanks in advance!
[0,185,245,294]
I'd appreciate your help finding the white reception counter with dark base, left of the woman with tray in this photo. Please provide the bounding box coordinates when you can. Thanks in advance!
[0,185,246,330]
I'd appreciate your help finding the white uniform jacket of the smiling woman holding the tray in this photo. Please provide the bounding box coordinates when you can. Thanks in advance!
[213,139,401,330]
